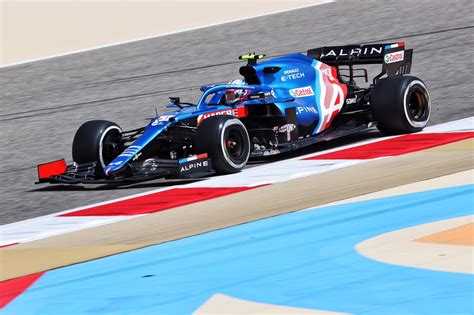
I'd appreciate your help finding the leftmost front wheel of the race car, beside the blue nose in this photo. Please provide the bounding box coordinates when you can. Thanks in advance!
[72,120,123,177]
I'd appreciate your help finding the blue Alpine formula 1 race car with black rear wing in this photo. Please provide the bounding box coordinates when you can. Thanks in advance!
[38,43,430,184]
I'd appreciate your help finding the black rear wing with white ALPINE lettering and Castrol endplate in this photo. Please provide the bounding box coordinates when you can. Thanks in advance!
[307,42,413,81]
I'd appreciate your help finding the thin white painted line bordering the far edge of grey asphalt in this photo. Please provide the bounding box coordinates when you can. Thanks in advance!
[0,0,335,69]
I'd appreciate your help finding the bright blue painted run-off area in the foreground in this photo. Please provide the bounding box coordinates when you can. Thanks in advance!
[3,185,474,314]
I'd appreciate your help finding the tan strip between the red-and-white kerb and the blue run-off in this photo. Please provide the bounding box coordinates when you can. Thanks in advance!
[0,140,474,280]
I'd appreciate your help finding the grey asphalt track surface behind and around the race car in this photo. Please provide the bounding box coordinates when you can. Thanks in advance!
[0,0,474,224]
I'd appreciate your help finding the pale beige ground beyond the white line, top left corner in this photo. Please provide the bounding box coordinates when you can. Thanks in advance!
[0,0,324,65]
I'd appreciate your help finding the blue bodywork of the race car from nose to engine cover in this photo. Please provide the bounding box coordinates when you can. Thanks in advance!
[104,54,345,175]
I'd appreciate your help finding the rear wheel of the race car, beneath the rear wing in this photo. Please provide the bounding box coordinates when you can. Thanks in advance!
[371,76,431,134]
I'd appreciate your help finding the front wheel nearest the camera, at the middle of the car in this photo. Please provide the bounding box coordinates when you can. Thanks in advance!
[194,115,250,174]
